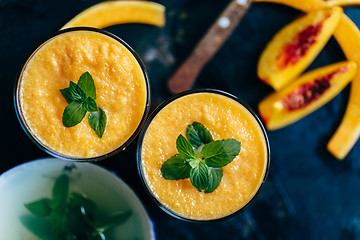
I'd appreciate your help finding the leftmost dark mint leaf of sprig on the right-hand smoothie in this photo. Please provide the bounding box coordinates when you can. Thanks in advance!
[161,154,191,180]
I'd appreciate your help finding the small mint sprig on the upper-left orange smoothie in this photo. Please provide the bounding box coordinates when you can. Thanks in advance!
[60,72,107,138]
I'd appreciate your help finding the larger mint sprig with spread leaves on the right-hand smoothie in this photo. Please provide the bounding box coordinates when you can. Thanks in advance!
[161,122,241,193]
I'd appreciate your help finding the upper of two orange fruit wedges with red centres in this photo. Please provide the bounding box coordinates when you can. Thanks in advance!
[257,7,343,90]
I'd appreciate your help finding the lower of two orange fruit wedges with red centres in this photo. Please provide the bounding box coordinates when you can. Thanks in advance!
[259,61,357,130]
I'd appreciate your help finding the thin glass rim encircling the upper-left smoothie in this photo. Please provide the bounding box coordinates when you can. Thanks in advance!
[13,27,151,162]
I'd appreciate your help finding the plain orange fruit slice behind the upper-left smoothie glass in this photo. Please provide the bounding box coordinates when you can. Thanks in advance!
[62,1,165,29]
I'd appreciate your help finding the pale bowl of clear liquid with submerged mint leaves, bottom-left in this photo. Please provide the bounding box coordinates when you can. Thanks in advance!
[0,158,154,240]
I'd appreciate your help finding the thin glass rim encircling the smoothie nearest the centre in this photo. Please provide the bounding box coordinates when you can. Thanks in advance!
[136,88,270,223]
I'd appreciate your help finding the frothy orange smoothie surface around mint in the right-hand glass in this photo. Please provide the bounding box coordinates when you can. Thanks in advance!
[139,92,269,220]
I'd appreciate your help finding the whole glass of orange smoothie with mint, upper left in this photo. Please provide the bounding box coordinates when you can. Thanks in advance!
[14,28,150,161]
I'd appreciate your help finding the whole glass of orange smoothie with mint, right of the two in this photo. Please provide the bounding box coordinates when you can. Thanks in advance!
[137,89,270,222]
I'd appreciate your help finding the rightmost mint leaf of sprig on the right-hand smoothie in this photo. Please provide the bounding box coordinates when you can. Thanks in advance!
[201,139,241,168]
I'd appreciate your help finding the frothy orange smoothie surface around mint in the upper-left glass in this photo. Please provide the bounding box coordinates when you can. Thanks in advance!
[18,31,147,158]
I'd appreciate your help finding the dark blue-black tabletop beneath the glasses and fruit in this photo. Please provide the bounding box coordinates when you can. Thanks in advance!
[0,0,360,240]
